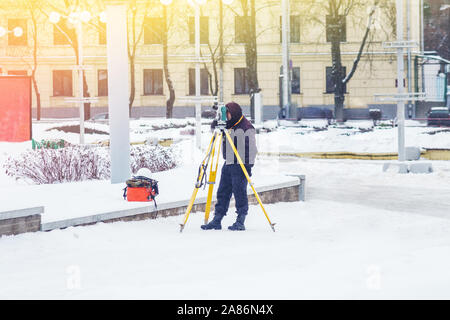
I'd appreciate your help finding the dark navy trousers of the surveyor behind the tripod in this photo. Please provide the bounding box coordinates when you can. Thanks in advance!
[214,164,251,216]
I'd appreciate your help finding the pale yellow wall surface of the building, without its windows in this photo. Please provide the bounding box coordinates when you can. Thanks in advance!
[0,0,420,115]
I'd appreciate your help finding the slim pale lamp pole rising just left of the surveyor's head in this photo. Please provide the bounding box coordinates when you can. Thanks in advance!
[195,4,202,149]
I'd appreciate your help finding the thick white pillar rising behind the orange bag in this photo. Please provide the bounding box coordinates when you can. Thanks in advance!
[106,3,131,183]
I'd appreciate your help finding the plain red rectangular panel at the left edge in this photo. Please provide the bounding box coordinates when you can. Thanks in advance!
[0,76,31,142]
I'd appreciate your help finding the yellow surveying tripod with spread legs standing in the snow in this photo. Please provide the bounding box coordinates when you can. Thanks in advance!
[180,128,275,232]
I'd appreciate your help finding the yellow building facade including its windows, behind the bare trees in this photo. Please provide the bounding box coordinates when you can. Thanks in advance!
[0,0,421,118]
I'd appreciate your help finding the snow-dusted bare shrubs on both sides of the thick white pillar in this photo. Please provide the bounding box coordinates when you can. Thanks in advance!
[3,146,177,184]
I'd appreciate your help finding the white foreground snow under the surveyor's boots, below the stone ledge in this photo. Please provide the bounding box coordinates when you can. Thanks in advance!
[0,196,450,299]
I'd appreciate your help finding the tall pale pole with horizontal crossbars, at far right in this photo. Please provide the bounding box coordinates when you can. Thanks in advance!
[396,0,405,161]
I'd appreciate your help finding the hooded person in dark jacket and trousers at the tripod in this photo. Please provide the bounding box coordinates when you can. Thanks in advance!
[201,102,257,230]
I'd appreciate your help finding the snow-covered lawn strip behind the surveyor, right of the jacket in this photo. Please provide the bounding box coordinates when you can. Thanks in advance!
[258,121,450,152]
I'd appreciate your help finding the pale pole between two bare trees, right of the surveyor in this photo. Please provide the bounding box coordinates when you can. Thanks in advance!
[281,0,291,118]
